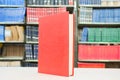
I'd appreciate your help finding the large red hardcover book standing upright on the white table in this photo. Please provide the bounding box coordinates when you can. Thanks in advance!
[38,12,74,76]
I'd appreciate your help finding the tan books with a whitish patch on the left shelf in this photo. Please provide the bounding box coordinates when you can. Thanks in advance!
[4,26,24,42]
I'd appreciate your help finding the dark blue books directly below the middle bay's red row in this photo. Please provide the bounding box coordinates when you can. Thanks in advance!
[26,26,38,41]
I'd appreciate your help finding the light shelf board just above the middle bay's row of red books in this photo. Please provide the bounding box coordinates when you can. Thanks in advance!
[27,5,74,8]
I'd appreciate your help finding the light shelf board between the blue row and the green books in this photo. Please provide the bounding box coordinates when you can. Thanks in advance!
[79,22,120,26]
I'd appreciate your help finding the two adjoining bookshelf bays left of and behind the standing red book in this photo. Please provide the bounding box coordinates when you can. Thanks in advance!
[0,0,77,67]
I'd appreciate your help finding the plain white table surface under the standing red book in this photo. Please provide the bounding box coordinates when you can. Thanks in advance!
[0,67,120,80]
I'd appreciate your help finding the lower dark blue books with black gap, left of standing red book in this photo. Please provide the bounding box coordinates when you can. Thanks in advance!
[25,44,38,60]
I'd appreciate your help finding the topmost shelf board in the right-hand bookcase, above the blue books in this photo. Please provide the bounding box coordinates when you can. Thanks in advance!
[79,5,120,8]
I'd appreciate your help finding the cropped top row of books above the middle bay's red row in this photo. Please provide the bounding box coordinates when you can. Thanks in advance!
[27,0,73,5]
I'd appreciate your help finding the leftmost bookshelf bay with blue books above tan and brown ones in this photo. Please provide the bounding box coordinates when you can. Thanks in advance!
[0,0,25,67]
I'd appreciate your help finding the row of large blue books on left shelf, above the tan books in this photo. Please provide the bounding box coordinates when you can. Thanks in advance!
[0,8,25,22]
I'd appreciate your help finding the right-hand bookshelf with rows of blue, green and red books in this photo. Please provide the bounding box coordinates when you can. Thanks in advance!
[77,0,120,68]
